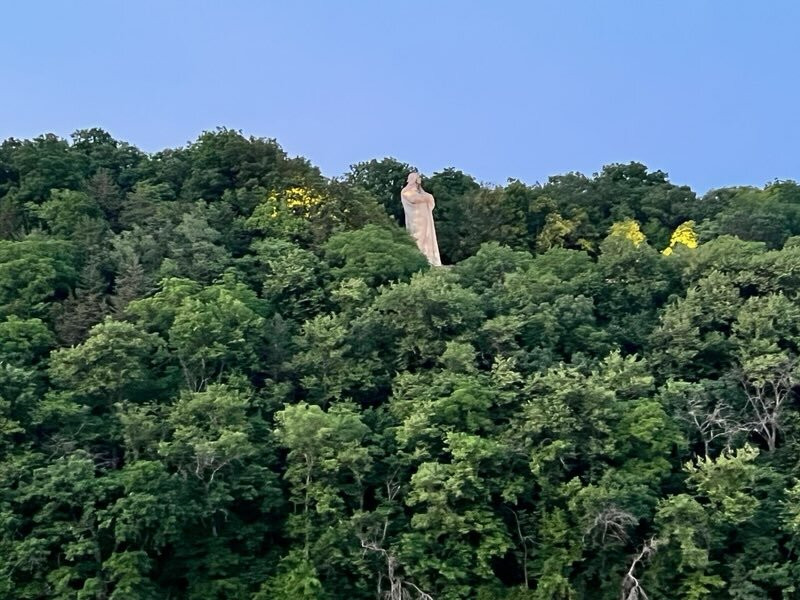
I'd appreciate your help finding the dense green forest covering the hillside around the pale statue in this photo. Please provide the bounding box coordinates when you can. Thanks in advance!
[0,129,800,600]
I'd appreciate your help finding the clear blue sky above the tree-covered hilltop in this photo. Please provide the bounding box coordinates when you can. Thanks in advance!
[0,0,800,191]
